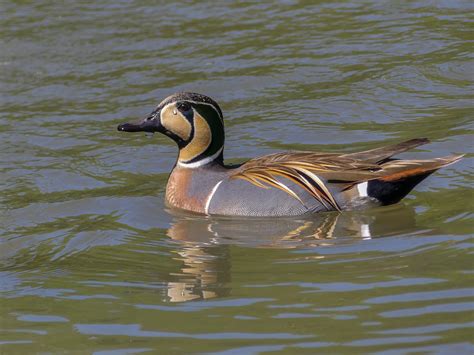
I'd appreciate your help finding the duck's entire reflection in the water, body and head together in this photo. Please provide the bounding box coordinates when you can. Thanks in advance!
[163,206,415,302]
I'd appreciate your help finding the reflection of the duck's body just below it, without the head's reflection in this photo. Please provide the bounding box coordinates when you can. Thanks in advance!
[168,205,415,247]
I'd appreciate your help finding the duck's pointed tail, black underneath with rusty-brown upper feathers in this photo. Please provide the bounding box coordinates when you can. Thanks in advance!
[367,155,464,205]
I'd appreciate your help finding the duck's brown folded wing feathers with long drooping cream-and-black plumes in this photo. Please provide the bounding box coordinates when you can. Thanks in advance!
[230,139,461,210]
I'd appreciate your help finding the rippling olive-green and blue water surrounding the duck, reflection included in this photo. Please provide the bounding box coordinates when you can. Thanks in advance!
[0,1,474,354]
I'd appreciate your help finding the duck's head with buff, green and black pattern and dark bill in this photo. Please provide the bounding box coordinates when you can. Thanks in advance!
[117,92,224,167]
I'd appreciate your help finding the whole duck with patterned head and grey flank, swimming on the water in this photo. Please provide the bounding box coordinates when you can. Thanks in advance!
[117,92,463,217]
